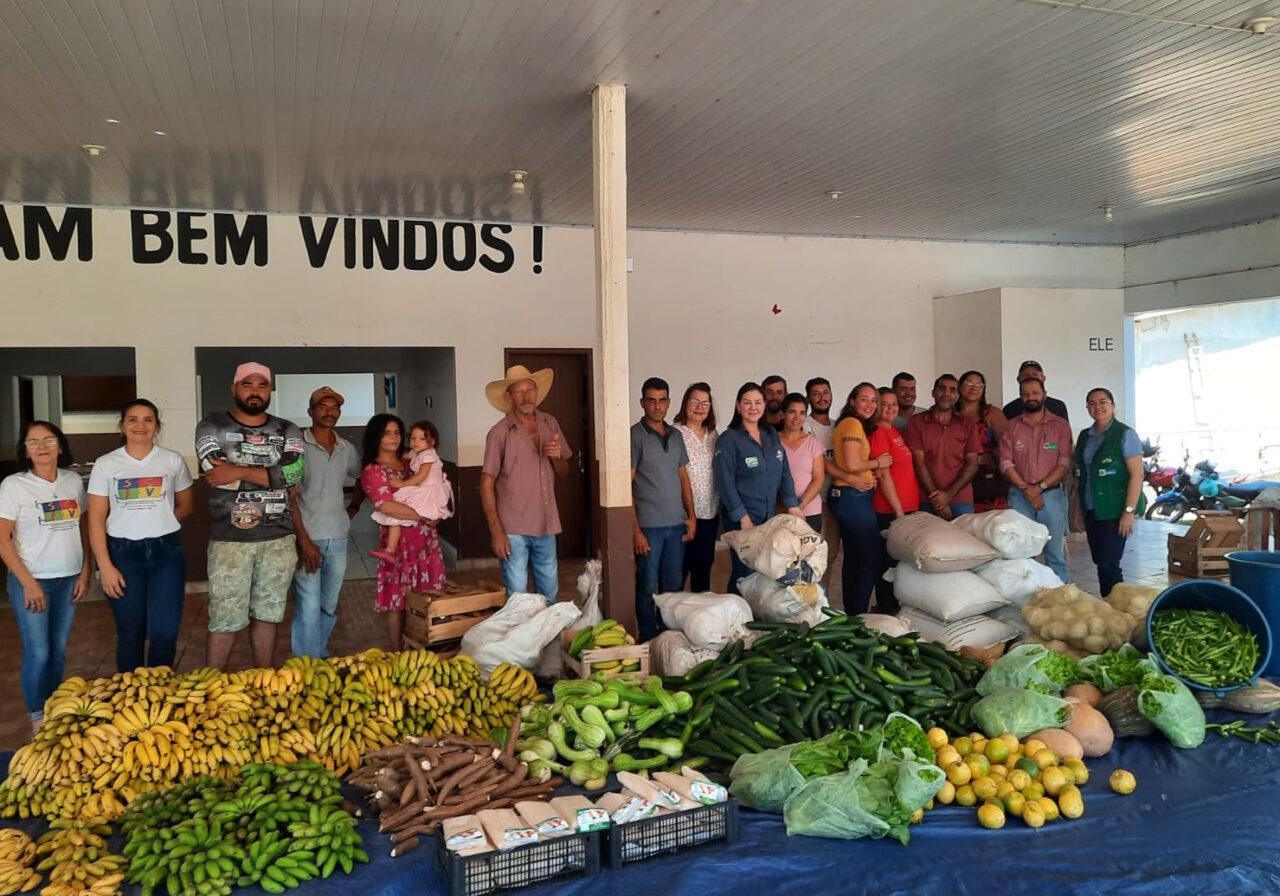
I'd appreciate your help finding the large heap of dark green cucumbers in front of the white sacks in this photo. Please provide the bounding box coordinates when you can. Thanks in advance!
[655,609,984,769]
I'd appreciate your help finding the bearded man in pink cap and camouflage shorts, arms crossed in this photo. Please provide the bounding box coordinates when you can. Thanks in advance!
[196,361,306,669]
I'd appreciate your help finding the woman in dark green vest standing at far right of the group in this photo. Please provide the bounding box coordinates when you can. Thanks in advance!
[1075,387,1144,598]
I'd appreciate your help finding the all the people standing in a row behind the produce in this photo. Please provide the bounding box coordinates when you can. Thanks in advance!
[0,361,1142,727]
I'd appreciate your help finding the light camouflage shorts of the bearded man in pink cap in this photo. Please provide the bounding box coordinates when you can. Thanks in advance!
[209,535,298,632]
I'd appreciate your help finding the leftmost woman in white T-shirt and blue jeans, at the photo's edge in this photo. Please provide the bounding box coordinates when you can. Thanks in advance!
[0,420,90,731]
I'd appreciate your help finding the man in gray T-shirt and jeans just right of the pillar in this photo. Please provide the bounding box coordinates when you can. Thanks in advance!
[631,376,698,641]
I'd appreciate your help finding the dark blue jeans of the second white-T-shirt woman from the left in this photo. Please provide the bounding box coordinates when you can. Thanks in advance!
[106,532,187,672]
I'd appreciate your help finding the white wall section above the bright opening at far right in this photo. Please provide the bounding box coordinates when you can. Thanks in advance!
[1124,220,1280,314]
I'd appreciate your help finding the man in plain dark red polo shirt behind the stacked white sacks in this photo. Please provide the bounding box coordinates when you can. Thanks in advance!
[906,374,982,520]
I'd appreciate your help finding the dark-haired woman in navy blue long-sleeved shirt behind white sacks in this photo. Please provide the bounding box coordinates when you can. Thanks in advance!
[712,383,804,594]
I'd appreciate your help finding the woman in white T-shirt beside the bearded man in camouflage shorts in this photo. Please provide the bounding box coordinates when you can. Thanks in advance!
[88,398,195,672]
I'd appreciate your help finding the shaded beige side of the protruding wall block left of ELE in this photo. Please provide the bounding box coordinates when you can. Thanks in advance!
[936,289,1006,406]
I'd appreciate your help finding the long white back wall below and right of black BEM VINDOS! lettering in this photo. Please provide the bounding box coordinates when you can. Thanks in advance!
[0,209,1123,465]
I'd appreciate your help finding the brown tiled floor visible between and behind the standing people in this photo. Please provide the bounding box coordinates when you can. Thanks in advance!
[0,522,1184,749]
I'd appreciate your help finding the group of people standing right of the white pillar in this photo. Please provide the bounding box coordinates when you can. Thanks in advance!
[631,361,1143,639]
